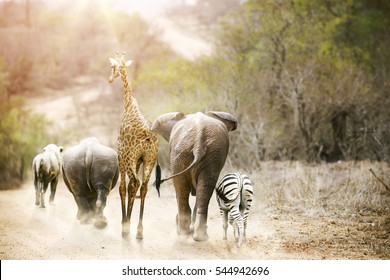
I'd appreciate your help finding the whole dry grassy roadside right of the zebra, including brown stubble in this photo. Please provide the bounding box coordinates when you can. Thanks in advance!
[251,162,390,259]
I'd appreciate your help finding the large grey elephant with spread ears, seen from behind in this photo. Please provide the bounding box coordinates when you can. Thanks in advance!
[152,112,237,241]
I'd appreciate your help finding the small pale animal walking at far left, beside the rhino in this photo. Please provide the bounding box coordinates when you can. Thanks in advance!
[32,144,63,208]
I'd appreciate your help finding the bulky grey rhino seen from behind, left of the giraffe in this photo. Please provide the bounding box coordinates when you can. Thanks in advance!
[62,138,119,228]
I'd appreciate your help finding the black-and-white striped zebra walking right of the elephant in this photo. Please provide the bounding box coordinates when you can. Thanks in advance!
[215,172,253,247]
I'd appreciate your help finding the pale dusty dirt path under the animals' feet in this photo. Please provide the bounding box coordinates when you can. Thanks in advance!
[0,182,278,260]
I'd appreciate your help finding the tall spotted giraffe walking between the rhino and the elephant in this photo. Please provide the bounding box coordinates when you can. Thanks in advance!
[109,53,159,239]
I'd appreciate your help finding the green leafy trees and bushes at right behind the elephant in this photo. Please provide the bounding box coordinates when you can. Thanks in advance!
[139,0,390,165]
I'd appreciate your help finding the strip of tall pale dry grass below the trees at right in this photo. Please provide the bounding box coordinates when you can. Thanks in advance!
[252,161,390,215]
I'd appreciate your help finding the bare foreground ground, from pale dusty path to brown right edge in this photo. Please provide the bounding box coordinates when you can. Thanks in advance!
[0,175,389,260]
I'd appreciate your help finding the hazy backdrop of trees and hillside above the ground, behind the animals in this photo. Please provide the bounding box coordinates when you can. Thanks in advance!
[0,0,390,188]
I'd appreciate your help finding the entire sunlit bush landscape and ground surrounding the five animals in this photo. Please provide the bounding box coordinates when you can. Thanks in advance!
[0,0,390,259]
